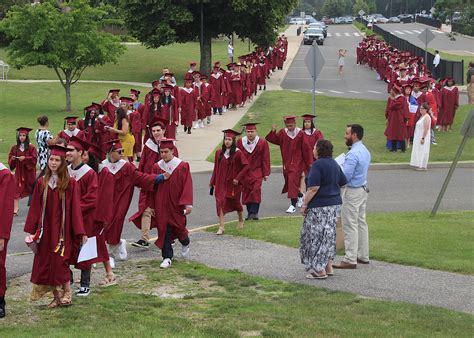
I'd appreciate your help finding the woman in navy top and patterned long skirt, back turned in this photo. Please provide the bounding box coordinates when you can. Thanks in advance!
[300,140,346,279]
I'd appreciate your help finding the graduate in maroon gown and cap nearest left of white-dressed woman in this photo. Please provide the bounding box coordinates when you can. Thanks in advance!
[385,85,410,152]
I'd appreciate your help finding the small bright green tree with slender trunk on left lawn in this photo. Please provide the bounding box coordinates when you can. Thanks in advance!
[0,0,125,111]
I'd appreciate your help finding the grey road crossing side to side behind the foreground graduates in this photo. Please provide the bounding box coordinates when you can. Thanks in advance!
[7,168,474,277]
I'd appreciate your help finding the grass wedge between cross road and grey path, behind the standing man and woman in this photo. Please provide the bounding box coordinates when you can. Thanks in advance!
[209,211,474,275]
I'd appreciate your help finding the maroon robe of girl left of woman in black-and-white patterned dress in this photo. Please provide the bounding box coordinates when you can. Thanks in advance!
[8,144,38,199]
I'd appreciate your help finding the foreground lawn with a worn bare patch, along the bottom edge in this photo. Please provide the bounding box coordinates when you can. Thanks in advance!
[0,260,472,337]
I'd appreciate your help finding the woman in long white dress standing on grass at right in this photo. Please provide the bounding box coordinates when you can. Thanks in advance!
[410,102,431,170]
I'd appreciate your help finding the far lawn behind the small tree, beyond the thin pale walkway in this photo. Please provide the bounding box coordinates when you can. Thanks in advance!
[0,39,253,83]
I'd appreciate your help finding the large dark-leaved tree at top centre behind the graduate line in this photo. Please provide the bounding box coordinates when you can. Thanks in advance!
[122,0,298,74]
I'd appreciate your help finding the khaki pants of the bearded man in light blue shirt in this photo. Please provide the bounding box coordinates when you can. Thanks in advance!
[341,188,369,264]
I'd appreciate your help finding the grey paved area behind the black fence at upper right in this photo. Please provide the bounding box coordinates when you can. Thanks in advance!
[378,23,474,57]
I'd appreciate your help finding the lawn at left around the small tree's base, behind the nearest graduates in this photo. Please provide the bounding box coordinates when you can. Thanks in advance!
[0,82,151,164]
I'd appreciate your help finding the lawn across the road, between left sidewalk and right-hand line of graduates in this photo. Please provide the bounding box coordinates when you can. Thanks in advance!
[208,91,474,165]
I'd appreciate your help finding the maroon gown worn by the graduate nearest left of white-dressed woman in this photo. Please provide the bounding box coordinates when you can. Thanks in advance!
[384,95,410,141]
